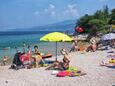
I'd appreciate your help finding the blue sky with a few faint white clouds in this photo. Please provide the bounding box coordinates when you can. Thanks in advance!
[0,0,115,31]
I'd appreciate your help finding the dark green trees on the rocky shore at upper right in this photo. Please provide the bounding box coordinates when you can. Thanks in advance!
[76,5,115,39]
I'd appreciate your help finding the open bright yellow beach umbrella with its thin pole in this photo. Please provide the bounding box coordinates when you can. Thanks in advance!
[40,32,72,60]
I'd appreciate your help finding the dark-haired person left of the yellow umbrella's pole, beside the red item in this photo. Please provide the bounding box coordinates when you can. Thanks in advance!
[32,45,45,67]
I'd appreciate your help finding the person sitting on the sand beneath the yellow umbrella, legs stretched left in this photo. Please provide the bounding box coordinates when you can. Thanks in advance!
[46,49,70,70]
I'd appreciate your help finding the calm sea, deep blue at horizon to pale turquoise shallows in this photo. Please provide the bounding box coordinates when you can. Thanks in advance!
[0,31,72,58]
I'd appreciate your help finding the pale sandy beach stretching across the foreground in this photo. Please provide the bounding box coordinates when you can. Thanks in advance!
[0,48,115,86]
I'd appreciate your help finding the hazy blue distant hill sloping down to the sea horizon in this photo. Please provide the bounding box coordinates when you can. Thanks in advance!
[12,20,77,31]
